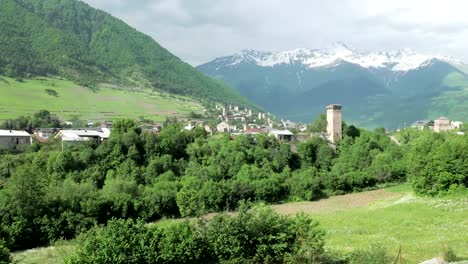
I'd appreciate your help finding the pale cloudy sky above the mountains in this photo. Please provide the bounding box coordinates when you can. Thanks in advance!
[84,0,468,65]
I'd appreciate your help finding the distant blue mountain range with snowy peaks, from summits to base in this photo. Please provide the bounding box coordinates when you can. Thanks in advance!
[197,43,468,128]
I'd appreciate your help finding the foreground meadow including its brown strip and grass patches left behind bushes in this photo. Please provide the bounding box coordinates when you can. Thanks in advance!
[14,185,468,264]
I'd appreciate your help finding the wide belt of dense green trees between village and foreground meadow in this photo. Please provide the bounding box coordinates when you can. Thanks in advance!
[0,117,400,252]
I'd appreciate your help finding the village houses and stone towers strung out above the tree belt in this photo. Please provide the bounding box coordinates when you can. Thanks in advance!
[0,104,464,150]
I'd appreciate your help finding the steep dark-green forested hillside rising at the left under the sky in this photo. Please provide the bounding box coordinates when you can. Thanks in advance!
[0,0,249,105]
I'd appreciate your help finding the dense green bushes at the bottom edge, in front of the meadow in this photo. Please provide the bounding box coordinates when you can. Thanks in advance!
[68,206,327,263]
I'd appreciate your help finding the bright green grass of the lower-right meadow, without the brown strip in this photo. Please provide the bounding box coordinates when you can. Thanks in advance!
[316,190,468,263]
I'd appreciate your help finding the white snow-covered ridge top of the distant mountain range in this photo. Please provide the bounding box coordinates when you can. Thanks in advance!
[218,43,460,71]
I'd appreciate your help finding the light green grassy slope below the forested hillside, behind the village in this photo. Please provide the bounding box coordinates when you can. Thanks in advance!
[0,76,202,121]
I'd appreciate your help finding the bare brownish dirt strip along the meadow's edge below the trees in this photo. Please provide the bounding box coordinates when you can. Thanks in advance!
[271,189,402,215]
